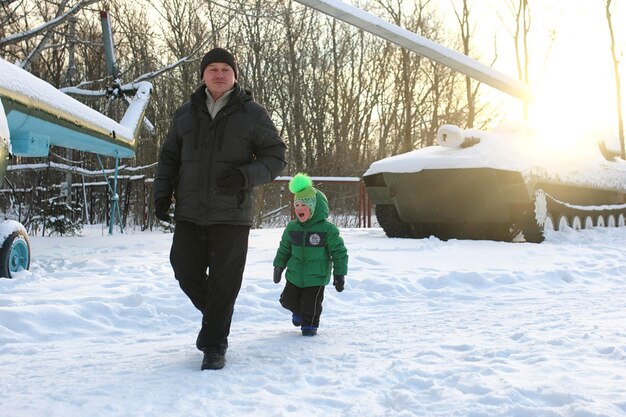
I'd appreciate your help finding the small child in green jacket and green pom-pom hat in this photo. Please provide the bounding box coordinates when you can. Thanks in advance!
[274,174,348,336]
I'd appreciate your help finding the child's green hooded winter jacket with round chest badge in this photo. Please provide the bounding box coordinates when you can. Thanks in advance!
[274,190,348,288]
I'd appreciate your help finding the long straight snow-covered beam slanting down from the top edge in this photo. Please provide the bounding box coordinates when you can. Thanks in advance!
[296,0,530,100]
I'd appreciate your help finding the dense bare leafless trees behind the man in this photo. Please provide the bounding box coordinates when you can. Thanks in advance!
[0,0,525,231]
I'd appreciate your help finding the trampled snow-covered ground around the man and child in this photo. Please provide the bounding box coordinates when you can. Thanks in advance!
[0,224,626,417]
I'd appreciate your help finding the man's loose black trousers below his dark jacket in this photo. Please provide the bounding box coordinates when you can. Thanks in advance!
[170,222,250,353]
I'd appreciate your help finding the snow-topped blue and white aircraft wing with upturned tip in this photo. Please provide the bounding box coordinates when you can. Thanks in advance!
[0,59,152,158]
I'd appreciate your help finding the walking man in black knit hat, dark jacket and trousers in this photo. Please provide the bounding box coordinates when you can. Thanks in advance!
[154,48,286,370]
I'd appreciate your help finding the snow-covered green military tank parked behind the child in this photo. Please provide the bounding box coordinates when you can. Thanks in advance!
[363,123,626,243]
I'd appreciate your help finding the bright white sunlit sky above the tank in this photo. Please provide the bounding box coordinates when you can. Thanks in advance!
[302,0,626,150]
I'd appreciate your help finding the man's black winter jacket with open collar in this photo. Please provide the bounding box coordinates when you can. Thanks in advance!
[154,83,286,226]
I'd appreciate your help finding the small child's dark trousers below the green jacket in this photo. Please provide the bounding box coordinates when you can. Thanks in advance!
[280,280,324,327]
